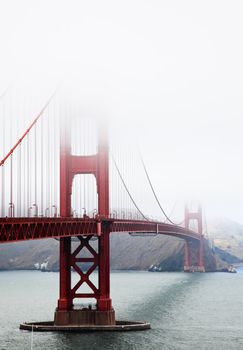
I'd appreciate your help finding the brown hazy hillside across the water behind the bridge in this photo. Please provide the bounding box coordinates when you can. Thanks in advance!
[0,221,235,271]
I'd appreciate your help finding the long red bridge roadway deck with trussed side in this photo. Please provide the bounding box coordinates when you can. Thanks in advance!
[0,217,200,243]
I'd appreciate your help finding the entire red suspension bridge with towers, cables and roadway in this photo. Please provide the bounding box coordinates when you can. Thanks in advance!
[0,87,205,330]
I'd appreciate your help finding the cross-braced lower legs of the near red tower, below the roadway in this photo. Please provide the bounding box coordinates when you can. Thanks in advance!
[54,231,116,326]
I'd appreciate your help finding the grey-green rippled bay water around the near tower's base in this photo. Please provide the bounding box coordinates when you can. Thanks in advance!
[0,269,243,350]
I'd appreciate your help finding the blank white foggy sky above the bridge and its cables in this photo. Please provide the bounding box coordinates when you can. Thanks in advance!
[0,0,243,224]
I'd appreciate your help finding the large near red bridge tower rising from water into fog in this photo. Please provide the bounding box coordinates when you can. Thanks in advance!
[54,119,115,325]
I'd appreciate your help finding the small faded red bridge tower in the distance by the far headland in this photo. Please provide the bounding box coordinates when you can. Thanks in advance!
[184,206,205,272]
